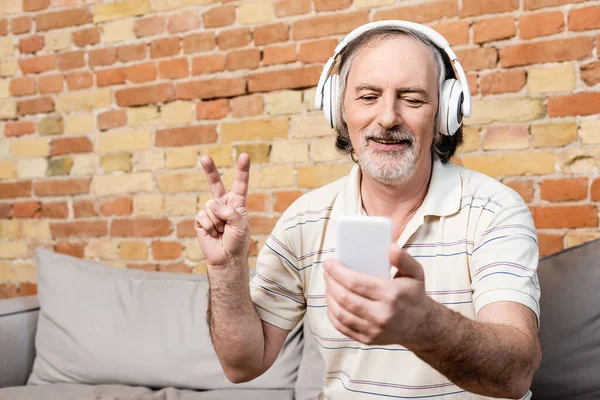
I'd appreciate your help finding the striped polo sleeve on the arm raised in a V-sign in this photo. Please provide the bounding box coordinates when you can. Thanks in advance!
[250,217,306,330]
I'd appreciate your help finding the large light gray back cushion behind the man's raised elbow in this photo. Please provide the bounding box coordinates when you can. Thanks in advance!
[28,249,302,389]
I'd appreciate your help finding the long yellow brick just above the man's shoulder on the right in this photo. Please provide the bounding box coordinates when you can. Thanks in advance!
[463,151,558,177]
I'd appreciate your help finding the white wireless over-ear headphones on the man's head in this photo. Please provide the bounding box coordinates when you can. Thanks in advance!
[315,20,471,136]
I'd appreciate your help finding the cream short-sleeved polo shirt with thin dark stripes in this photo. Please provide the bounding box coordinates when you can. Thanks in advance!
[250,160,540,400]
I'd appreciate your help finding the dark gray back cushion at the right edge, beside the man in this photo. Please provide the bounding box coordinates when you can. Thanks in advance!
[531,240,600,400]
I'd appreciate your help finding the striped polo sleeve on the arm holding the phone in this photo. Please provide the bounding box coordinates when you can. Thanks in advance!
[470,202,540,326]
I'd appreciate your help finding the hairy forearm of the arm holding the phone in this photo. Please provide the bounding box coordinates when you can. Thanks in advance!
[411,300,541,398]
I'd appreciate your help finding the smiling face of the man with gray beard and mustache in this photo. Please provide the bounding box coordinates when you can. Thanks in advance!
[343,36,438,185]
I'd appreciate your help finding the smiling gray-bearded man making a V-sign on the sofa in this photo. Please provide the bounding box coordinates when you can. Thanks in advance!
[196,22,541,399]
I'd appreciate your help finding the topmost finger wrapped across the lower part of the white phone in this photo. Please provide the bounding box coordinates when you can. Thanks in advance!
[324,259,386,300]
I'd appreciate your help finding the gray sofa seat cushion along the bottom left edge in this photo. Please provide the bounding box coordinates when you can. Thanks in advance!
[0,383,294,400]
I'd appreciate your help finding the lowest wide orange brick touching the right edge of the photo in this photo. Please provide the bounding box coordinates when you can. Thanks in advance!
[531,205,598,229]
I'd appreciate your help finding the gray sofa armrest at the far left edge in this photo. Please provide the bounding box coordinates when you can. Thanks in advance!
[0,296,40,388]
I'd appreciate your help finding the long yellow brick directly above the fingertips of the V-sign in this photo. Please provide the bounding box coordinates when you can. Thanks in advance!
[220,118,288,143]
